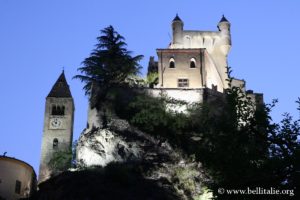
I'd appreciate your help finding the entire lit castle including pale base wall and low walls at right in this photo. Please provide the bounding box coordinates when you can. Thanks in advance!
[148,15,263,103]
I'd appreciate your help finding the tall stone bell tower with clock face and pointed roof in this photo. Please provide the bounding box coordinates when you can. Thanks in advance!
[38,71,75,183]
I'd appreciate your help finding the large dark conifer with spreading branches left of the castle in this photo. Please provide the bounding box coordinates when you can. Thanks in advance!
[74,26,143,102]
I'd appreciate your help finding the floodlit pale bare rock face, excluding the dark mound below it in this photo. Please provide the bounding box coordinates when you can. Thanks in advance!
[76,119,208,199]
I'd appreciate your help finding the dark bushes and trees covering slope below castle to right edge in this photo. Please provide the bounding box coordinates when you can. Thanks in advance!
[111,83,300,199]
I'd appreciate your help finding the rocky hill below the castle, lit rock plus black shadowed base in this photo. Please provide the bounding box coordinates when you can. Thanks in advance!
[32,113,210,200]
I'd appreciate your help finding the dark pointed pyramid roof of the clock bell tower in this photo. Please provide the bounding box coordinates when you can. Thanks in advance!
[47,71,72,98]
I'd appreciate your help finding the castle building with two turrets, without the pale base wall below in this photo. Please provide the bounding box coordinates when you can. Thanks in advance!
[157,15,231,92]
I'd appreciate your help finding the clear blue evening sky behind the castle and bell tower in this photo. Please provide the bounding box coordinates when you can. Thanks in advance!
[0,0,300,173]
